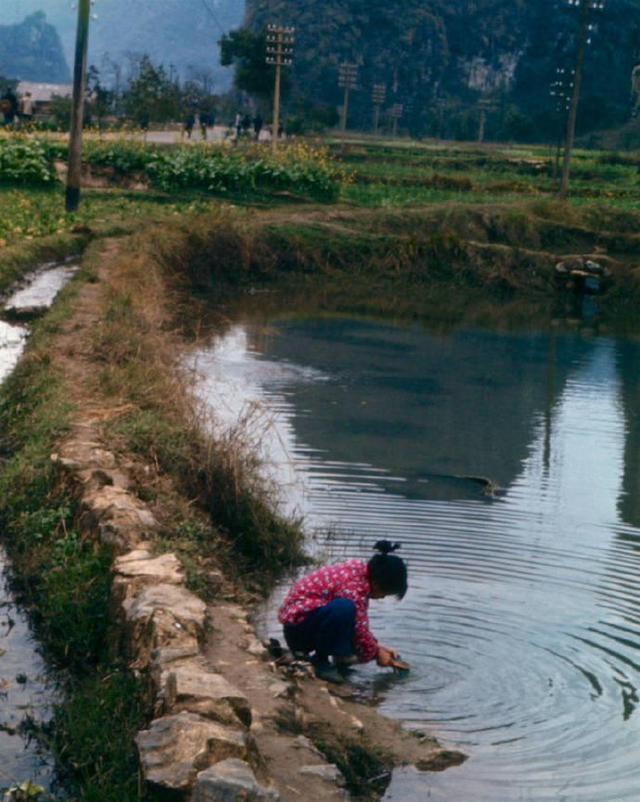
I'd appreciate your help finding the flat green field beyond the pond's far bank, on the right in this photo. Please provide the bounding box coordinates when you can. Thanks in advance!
[333,138,639,208]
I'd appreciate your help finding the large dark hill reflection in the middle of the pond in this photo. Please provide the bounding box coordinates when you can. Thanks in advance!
[262,318,591,498]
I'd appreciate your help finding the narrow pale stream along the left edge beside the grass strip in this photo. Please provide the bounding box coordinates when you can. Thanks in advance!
[0,264,77,797]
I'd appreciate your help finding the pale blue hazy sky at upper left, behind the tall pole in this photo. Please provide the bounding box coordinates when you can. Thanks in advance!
[0,0,244,89]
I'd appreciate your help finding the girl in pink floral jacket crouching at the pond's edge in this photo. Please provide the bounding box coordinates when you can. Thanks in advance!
[278,540,407,682]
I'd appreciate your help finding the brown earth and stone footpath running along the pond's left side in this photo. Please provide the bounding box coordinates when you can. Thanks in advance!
[13,227,464,802]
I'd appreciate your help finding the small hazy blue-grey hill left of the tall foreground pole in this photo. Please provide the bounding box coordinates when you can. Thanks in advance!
[0,11,70,83]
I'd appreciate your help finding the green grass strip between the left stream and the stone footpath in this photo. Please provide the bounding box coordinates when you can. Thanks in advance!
[0,260,147,802]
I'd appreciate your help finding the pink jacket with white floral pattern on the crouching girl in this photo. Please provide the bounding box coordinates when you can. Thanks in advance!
[278,560,378,663]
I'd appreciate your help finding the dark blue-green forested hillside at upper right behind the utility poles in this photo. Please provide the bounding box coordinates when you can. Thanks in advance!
[245,0,640,138]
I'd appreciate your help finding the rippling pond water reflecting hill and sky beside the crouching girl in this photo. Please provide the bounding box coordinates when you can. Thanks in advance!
[197,298,640,802]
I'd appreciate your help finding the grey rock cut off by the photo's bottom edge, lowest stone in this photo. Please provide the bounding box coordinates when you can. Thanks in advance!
[193,758,280,802]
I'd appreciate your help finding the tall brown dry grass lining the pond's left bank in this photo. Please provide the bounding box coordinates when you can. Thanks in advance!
[93,220,302,576]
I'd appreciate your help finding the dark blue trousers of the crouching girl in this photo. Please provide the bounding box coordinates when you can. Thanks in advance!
[284,598,356,660]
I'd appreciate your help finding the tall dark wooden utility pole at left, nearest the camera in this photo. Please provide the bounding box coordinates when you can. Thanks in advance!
[65,0,91,212]
